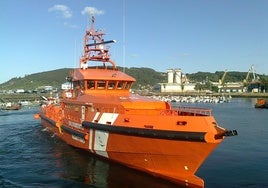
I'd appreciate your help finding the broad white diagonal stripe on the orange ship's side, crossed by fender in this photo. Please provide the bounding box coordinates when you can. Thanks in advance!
[93,113,118,158]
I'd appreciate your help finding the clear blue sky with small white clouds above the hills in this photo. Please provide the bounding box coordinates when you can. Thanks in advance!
[0,0,268,83]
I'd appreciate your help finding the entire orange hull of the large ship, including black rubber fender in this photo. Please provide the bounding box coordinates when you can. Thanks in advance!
[40,100,232,187]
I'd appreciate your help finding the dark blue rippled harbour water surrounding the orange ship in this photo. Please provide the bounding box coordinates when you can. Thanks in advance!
[0,98,268,188]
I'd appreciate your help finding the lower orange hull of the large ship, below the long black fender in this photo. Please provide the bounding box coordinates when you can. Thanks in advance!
[41,115,219,187]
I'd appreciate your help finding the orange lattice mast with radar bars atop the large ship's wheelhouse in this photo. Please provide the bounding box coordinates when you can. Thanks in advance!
[80,16,116,69]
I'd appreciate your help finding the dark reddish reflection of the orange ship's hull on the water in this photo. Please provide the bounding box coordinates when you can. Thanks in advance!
[45,133,178,188]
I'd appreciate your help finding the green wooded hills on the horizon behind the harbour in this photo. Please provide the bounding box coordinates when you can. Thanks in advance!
[0,67,268,90]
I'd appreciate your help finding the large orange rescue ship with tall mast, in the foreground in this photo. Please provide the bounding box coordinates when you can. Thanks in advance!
[35,16,237,187]
